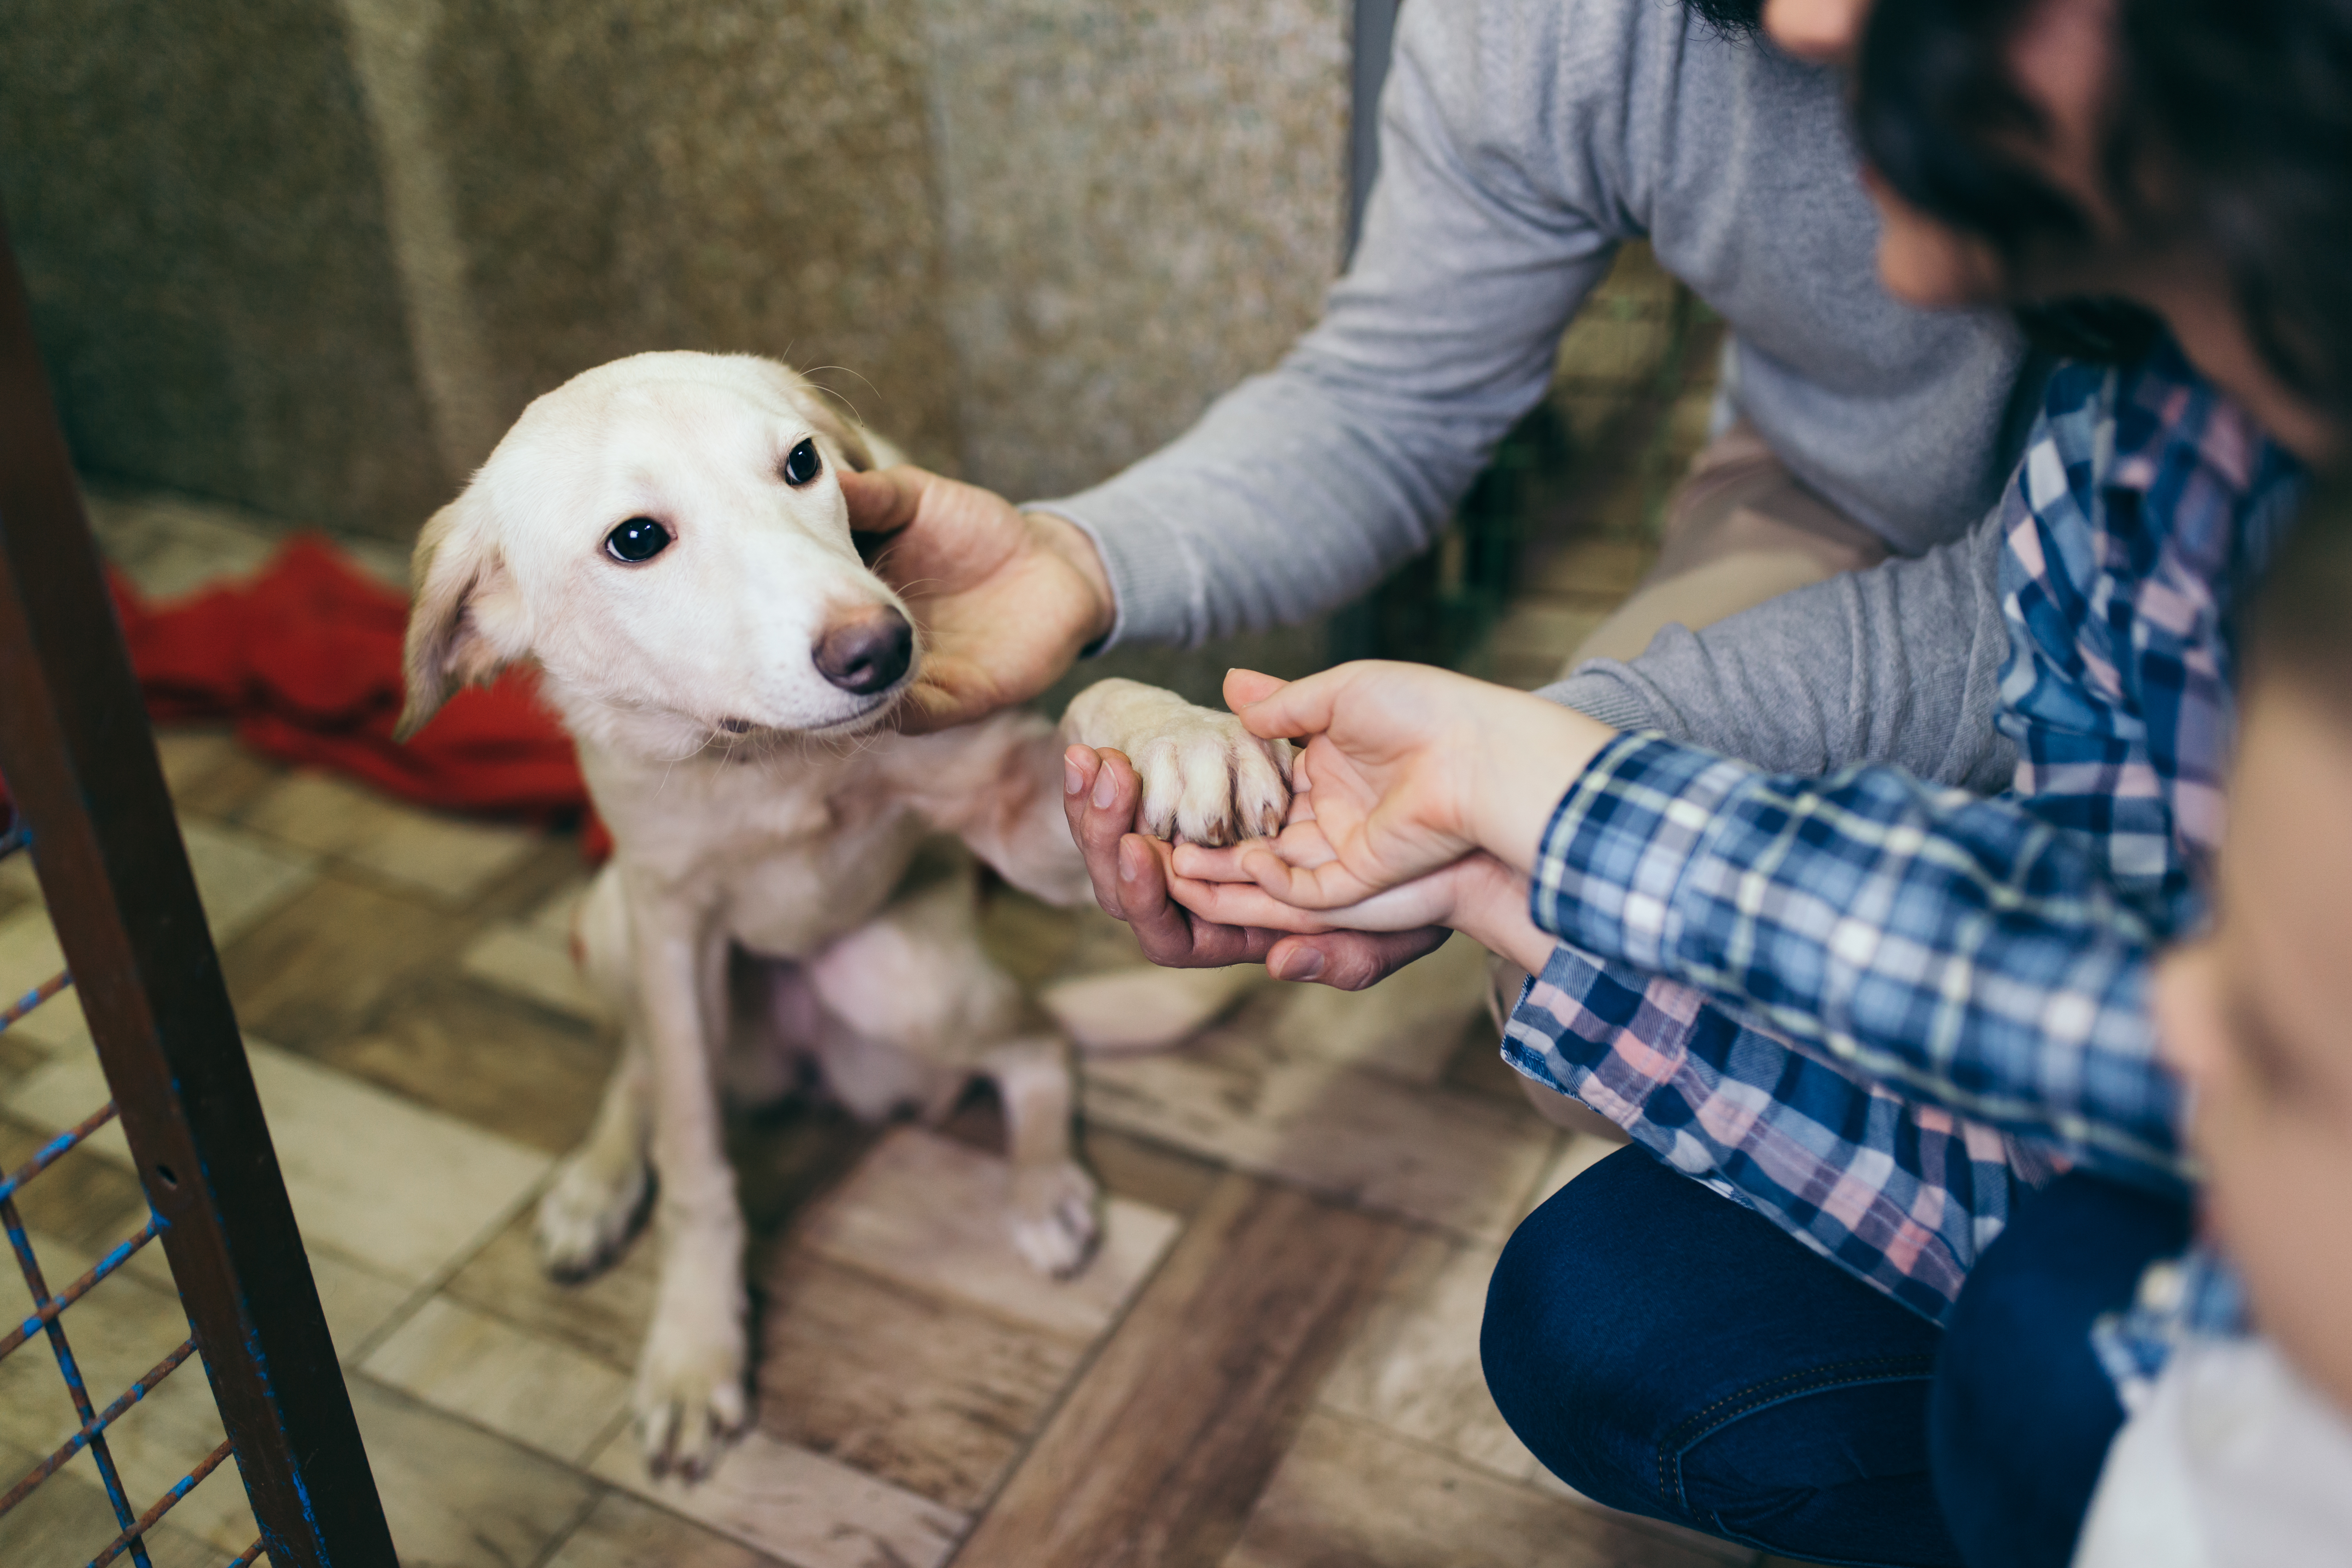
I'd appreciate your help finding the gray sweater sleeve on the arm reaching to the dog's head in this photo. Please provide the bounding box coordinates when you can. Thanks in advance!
[1037,5,1625,646]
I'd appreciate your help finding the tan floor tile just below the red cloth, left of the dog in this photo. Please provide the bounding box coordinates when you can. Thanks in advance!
[240,771,539,905]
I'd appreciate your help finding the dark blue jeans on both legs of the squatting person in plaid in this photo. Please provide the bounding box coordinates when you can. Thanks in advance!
[1479,1149,2180,1568]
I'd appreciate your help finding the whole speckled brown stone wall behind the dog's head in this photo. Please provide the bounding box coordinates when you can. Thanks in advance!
[0,0,1348,550]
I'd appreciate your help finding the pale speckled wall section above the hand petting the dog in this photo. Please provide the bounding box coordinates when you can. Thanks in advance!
[927,0,1348,498]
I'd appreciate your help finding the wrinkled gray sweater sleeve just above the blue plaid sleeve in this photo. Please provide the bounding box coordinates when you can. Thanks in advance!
[1540,510,2018,795]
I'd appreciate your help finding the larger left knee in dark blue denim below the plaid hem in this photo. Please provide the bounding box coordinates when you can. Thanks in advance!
[1479,1149,1959,1566]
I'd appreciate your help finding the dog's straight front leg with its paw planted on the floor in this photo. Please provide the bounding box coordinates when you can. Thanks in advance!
[630,900,748,1479]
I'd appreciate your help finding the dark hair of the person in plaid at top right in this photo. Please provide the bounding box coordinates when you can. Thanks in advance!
[1856,0,2352,421]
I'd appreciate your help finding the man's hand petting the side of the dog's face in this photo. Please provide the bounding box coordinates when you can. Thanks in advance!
[840,463,1115,733]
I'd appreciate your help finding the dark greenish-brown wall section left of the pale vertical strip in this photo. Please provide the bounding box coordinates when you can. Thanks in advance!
[0,0,447,527]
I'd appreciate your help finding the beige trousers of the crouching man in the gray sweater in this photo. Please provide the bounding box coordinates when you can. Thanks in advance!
[1494,421,1886,1142]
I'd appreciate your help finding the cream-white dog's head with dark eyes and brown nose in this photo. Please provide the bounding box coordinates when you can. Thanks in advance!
[400,352,920,757]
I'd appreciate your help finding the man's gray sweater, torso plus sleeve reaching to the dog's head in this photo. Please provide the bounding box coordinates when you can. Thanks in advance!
[1042,0,2023,677]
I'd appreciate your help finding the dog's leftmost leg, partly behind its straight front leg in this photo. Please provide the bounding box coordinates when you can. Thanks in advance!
[539,867,654,1279]
